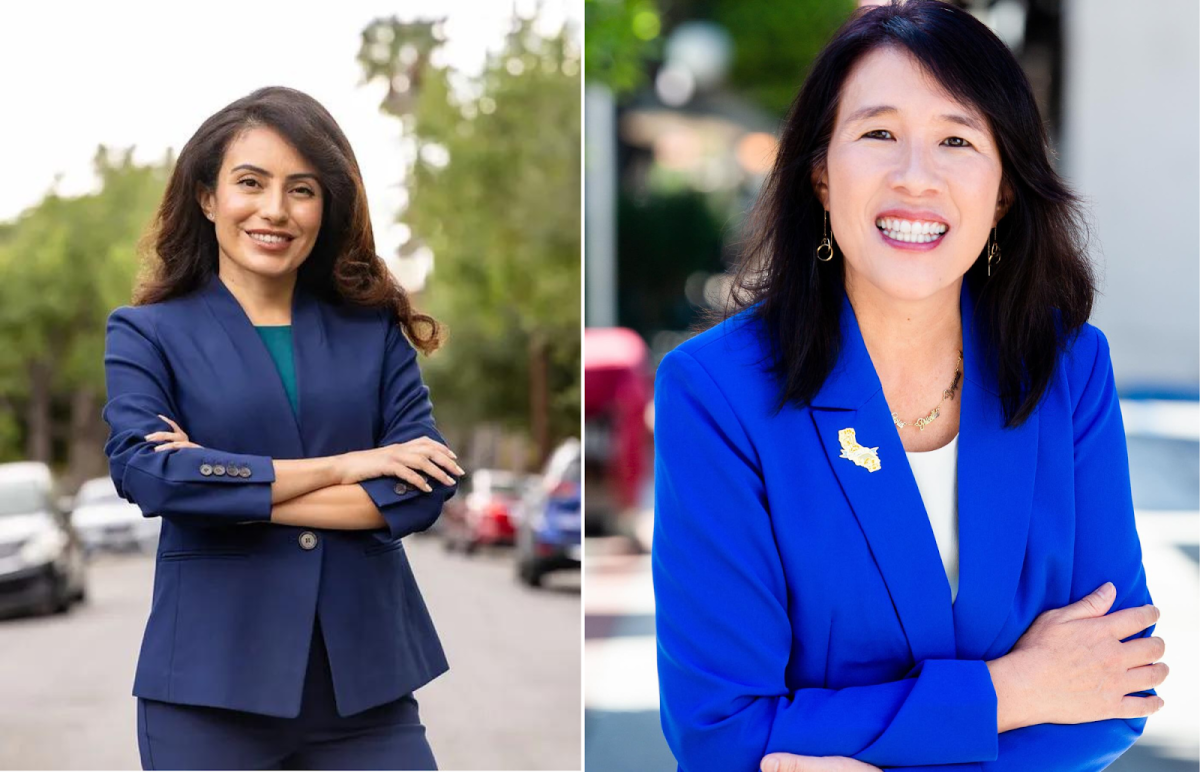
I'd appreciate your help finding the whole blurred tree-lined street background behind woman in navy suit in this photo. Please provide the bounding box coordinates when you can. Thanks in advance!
[0,0,582,770]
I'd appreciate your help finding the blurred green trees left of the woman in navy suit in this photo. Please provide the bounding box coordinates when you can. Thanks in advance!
[0,146,173,470]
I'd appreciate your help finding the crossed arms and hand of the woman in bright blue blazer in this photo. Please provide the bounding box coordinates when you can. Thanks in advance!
[653,337,1165,772]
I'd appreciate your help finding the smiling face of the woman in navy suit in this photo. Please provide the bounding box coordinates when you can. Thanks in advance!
[197,126,324,280]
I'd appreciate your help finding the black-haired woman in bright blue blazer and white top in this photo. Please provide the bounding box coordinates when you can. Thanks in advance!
[653,0,1166,772]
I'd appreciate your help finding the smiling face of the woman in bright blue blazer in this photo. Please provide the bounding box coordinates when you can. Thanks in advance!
[815,48,1004,301]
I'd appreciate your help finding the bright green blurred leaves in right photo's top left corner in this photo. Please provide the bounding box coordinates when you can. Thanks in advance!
[583,0,662,94]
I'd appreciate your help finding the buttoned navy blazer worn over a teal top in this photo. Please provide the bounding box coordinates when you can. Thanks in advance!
[103,276,454,718]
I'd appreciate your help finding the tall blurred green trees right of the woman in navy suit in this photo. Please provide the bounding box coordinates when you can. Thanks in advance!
[359,18,581,454]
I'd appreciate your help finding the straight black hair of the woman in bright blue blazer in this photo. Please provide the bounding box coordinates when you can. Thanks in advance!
[718,0,1096,426]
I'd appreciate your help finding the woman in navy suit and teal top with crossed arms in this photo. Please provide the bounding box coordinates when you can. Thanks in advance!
[104,88,462,770]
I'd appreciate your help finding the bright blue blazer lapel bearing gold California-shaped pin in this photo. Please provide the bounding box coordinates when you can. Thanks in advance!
[812,294,955,662]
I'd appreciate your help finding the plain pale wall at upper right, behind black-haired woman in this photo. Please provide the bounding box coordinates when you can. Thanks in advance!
[1060,0,1200,396]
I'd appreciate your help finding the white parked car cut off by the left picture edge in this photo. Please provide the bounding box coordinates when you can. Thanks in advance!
[0,461,86,614]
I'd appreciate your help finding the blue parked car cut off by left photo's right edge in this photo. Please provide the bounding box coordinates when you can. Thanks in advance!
[516,439,582,587]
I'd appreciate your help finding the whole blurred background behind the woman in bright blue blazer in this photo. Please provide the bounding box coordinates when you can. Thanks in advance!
[584,0,1200,772]
